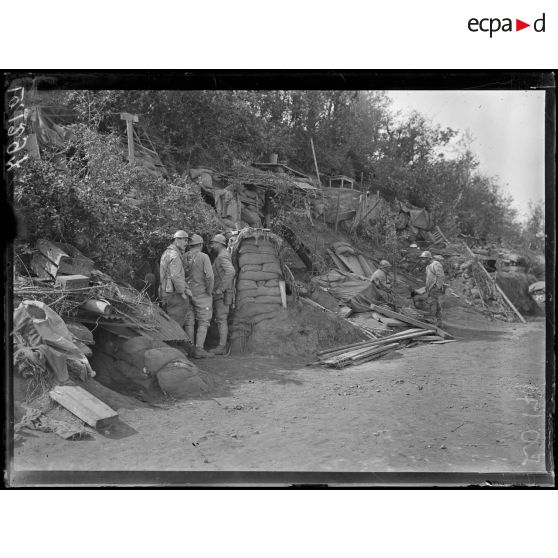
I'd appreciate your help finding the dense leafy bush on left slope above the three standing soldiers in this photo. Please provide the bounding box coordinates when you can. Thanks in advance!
[14,126,221,282]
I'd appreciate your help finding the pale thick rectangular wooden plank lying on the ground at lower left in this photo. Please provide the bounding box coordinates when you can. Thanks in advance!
[49,386,118,428]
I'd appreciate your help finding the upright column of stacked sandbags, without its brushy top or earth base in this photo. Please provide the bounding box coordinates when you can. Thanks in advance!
[234,238,283,324]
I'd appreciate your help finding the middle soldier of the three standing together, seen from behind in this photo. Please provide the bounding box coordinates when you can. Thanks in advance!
[185,234,214,358]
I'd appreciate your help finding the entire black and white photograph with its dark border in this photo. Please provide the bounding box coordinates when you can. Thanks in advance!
[4,71,555,487]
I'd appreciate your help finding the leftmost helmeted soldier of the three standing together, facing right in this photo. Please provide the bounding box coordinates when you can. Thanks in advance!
[159,230,191,327]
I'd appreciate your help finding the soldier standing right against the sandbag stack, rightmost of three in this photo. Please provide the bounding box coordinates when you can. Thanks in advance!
[210,234,235,355]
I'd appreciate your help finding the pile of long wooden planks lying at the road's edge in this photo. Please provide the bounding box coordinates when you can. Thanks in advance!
[312,328,443,368]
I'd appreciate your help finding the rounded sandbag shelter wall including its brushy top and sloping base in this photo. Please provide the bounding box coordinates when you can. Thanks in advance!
[231,228,285,350]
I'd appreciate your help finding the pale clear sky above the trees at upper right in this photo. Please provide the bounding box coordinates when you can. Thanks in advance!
[388,91,544,218]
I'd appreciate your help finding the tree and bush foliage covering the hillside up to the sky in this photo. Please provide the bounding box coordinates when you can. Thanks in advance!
[15,90,544,282]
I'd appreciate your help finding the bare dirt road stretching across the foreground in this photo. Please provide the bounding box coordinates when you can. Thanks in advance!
[10,320,545,472]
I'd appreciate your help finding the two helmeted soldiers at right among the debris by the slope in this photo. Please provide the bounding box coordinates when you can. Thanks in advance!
[370,250,445,327]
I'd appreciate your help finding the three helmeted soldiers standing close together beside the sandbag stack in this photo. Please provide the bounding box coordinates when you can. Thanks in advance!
[159,230,235,358]
